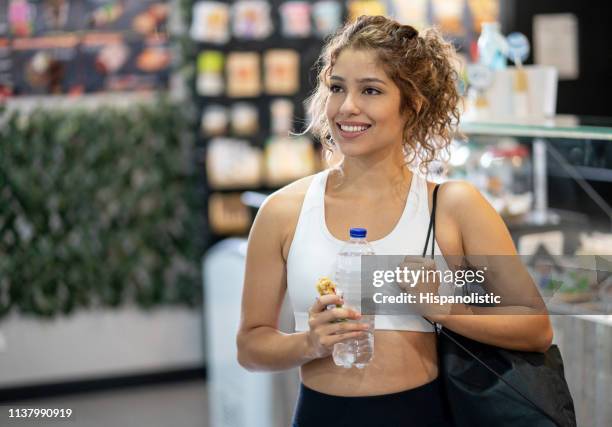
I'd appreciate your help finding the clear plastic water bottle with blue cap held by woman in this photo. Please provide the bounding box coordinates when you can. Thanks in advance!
[332,228,374,369]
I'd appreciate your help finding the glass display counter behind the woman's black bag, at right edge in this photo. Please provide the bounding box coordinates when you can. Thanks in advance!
[460,116,612,427]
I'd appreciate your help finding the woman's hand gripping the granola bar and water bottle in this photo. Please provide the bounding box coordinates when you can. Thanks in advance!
[308,295,369,359]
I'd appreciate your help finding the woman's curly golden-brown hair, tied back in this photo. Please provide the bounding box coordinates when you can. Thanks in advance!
[305,16,460,173]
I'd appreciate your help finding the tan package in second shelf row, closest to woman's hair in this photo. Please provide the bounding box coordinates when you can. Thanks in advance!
[264,49,300,95]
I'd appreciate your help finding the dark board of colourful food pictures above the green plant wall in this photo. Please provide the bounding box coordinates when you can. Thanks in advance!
[0,0,171,96]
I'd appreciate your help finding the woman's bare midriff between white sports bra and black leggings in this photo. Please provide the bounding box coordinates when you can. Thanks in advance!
[300,330,438,396]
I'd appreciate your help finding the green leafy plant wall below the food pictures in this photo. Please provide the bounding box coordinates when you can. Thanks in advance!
[0,99,203,318]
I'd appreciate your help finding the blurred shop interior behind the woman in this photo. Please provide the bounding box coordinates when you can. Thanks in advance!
[0,0,612,427]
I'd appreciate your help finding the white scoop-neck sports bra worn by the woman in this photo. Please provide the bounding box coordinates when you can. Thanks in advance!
[287,169,447,332]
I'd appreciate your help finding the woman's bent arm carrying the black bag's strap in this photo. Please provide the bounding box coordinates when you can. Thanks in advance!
[432,182,553,352]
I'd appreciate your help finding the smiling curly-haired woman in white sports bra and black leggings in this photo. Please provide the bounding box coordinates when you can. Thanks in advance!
[237,16,552,427]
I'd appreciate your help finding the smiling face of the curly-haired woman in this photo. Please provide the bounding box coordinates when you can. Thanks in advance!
[325,49,406,157]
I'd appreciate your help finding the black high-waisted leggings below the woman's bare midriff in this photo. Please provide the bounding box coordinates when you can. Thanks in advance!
[293,379,452,427]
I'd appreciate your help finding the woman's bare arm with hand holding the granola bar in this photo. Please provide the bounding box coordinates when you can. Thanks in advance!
[236,190,368,371]
